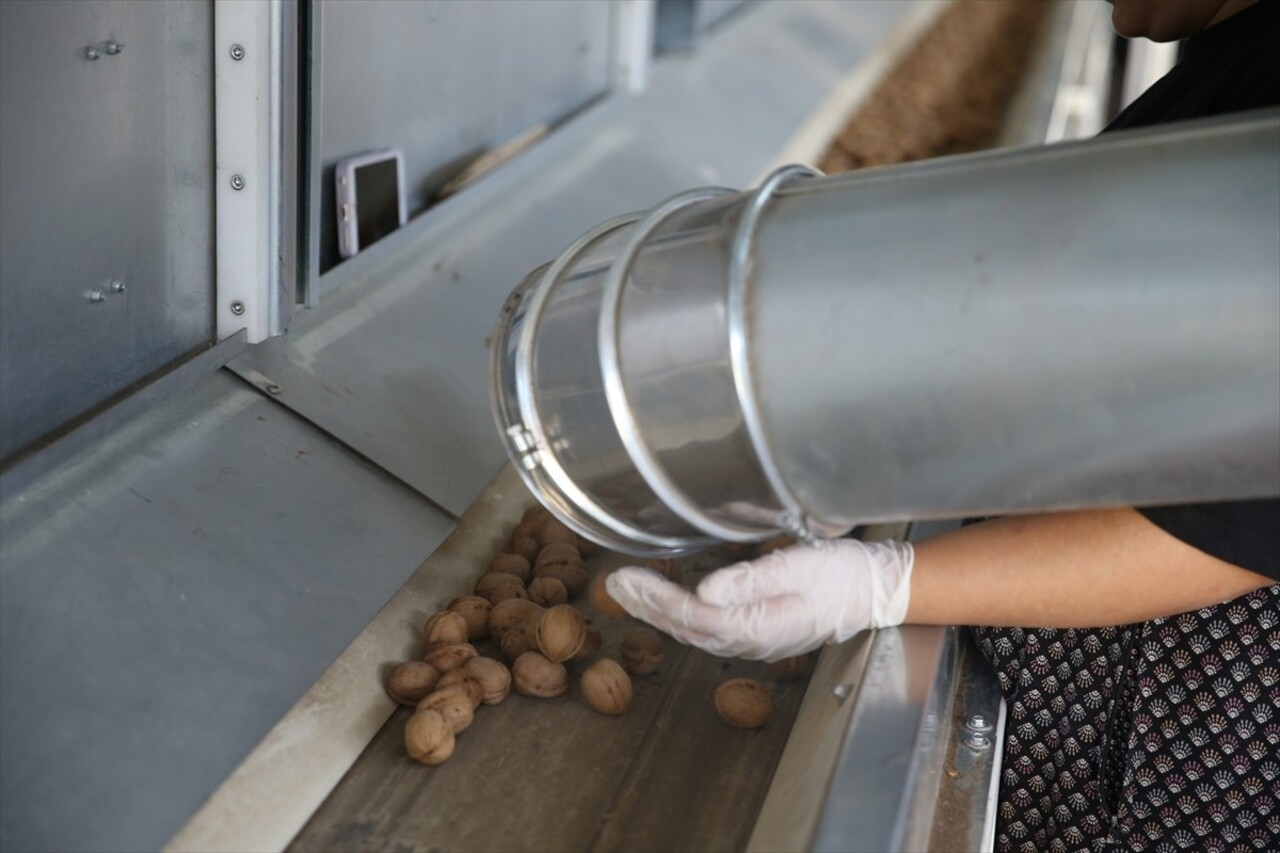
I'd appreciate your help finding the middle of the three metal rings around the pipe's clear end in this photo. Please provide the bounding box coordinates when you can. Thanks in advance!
[598,187,759,544]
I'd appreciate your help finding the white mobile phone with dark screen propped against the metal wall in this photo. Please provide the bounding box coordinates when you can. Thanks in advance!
[334,149,408,257]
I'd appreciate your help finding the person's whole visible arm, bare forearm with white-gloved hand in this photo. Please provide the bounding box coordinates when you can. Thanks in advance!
[607,510,1271,660]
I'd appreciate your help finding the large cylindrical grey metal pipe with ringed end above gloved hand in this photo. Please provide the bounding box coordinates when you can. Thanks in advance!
[499,110,1280,538]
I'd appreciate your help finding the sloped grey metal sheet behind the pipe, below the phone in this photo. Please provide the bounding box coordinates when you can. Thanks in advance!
[233,1,909,514]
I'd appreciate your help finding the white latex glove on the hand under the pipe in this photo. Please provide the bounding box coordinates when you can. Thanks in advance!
[605,539,915,661]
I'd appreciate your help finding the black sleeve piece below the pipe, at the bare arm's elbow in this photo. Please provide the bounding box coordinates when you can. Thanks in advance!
[1138,498,1280,580]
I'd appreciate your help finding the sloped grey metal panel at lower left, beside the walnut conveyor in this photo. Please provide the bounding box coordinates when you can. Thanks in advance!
[0,371,453,850]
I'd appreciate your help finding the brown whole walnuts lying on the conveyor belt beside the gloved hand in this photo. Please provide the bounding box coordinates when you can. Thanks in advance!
[387,507,808,765]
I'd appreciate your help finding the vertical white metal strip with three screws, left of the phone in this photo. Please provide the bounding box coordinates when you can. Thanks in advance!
[214,0,283,343]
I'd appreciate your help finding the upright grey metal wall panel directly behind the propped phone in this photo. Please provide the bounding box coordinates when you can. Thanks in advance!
[314,0,611,272]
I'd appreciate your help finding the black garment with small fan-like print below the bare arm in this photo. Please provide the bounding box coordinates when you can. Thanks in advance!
[974,585,1280,853]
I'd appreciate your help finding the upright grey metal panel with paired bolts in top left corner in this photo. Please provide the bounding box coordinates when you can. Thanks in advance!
[0,0,212,459]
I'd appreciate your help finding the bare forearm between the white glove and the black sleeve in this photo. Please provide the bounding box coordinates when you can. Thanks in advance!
[906,508,1271,628]
